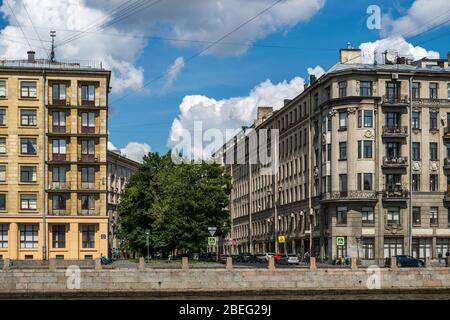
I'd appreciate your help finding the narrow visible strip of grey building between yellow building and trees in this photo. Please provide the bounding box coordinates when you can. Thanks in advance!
[107,150,140,257]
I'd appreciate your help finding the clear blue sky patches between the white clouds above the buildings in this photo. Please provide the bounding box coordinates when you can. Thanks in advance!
[0,0,450,160]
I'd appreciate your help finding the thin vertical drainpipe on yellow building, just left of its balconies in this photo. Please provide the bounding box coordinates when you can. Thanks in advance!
[42,69,47,260]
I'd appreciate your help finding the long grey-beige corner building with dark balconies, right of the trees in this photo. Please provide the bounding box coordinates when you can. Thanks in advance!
[218,48,450,263]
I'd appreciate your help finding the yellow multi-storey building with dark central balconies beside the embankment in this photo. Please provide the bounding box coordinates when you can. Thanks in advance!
[0,52,110,259]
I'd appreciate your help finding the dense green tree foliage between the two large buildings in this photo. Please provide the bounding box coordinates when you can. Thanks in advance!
[118,153,231,255]
